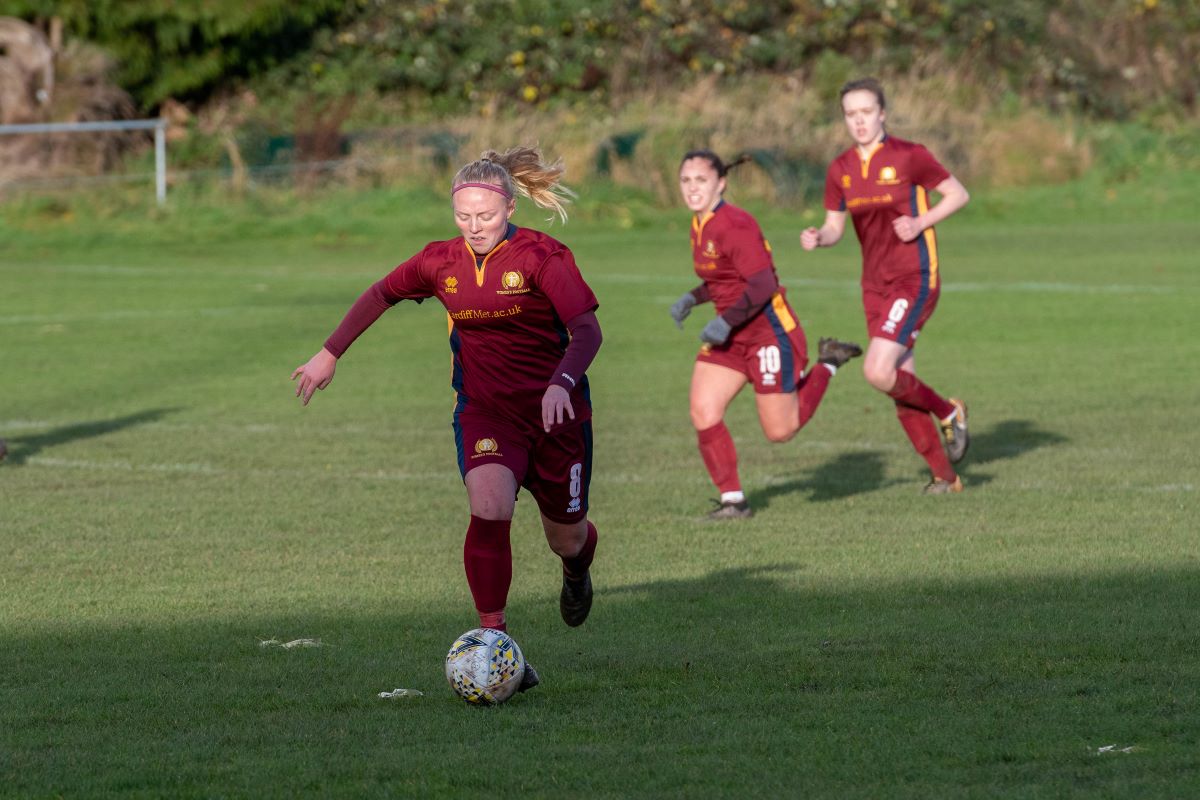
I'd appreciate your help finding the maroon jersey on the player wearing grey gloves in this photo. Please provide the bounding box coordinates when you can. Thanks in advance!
[691,200,798,342]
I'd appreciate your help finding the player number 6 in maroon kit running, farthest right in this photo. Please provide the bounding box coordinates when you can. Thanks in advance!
[800,78,970,494]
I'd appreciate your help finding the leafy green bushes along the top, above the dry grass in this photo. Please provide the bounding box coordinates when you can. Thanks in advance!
[10,0,1200,119]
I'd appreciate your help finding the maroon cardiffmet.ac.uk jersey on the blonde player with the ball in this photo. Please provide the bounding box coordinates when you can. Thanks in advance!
[380,225,598,429]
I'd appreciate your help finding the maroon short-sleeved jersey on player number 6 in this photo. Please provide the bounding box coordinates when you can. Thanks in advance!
[824,136,950,290]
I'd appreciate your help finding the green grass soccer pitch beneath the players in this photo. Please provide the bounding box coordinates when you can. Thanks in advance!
[0,180,1200,798]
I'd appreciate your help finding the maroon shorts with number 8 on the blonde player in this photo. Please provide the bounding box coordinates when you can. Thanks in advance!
[454,411,592,524]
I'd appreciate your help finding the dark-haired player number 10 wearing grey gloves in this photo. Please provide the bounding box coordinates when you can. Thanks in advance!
[671,150,863,519]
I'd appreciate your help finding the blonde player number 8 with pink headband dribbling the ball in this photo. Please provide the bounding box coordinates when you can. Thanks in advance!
[292,148,601,691]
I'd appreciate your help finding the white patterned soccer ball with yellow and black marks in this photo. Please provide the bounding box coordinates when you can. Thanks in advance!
[446,627,524,705]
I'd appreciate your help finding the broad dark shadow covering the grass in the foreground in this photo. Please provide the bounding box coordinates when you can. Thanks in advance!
[0,564,1200,796]
